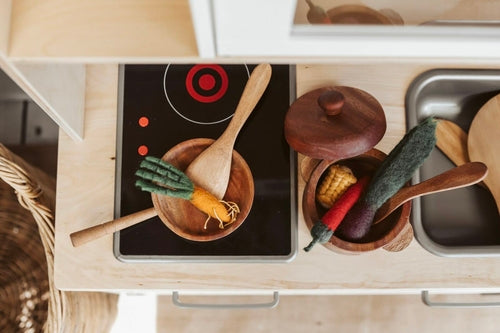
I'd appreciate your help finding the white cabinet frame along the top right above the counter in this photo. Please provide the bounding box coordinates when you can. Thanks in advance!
[211,0,500,61]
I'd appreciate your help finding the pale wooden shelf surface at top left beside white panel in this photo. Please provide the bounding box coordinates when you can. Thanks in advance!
[9,0,198,58]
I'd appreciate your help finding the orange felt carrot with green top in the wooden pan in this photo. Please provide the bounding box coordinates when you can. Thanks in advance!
[135,156,240,229]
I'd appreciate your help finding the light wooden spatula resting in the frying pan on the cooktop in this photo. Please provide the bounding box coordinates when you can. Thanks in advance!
[185,64,271,199]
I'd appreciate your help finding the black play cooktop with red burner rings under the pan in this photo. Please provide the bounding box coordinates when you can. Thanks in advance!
[114,64,297,261]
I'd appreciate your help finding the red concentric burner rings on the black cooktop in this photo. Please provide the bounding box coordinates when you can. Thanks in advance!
[186,65,229,103]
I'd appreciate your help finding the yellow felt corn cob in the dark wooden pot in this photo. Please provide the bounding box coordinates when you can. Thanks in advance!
[316,164,357,208]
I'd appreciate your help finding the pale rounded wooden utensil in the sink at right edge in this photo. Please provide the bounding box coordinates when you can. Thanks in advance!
[467,94,500,212]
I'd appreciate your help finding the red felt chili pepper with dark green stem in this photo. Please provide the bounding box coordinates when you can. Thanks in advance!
[304,176,370,252]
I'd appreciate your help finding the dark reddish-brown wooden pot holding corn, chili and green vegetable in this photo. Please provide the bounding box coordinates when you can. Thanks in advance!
[302,148,411,254]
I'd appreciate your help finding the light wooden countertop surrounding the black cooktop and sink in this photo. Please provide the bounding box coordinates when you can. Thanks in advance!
[51,61,500,294]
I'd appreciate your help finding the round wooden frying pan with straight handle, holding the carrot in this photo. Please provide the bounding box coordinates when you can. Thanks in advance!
[70,138,254,247]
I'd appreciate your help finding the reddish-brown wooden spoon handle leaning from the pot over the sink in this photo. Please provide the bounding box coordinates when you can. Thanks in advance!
[373,162,488,224]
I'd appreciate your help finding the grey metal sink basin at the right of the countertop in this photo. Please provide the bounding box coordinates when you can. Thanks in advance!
[406,69,500,256]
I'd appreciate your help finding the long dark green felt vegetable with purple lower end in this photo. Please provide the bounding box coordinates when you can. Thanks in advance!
[337,117,437,240]
